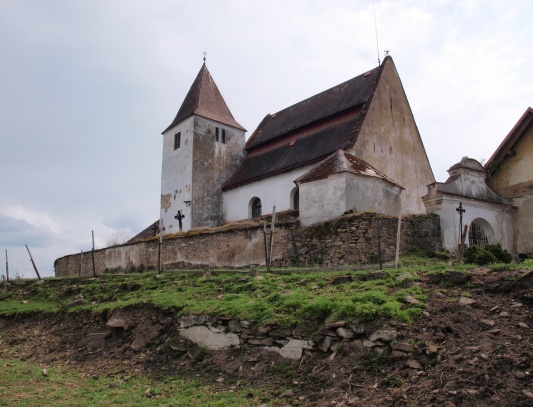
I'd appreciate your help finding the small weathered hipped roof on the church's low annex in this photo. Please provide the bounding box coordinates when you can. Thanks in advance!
[295,150,403,189]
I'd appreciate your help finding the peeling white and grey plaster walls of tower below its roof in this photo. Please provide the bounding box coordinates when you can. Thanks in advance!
[161,115,244,235]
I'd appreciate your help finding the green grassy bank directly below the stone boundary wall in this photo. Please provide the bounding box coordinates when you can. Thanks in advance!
[0,254,533,333]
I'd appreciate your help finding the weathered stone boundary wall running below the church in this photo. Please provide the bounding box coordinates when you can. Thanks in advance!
[54,212,442,277]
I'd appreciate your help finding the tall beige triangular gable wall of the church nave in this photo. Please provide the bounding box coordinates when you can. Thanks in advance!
[353,59,435,214]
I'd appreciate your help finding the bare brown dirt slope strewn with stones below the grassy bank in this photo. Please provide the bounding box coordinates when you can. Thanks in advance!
[0,269,533,407]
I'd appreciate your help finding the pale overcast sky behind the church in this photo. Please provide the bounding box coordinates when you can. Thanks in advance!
[0,0,533,277]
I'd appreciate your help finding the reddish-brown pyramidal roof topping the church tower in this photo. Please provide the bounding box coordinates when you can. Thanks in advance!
[163,62,246,133]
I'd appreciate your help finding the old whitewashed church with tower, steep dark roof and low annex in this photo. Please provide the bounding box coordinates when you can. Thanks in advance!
[159,56,435,236]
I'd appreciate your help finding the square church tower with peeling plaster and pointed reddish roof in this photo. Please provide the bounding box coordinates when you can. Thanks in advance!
[161,60,246,235]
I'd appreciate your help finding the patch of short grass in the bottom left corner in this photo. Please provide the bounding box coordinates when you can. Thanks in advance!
[0,360,276,407]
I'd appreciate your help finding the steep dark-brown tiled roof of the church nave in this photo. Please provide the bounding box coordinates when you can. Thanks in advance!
[223,57,392,190]
